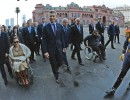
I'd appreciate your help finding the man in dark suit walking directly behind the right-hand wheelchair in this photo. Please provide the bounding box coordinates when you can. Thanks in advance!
[96,18,105,45]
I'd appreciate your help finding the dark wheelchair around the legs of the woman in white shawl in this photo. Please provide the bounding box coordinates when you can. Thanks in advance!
[12,60,34,86]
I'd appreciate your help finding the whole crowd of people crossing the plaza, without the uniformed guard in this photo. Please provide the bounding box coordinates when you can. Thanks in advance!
[0,10,124,91]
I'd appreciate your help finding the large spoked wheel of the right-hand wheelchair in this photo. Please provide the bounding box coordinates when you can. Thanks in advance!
[84,46,93,60]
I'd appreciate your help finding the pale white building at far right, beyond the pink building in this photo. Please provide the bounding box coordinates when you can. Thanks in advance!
[113,5,130,22]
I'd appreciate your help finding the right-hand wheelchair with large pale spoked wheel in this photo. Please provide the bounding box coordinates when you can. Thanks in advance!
[84,45,101,62]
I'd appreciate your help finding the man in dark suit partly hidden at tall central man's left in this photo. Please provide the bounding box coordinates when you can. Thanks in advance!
[37,17,46,61]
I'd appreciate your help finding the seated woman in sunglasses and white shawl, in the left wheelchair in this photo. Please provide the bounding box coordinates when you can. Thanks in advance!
[9,37,31,85]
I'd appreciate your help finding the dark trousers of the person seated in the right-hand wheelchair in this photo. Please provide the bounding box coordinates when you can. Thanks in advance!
[92,44,105,57]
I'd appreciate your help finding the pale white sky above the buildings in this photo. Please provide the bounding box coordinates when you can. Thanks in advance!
[0,0,130,25]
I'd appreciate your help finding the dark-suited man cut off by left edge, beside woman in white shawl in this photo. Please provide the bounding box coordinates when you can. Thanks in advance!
[0,29,12,85]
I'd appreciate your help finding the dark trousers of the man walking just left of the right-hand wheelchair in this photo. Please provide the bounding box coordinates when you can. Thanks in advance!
[71,43,82,63]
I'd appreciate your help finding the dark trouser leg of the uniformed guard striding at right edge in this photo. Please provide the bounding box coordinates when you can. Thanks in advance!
[113,63,130,89]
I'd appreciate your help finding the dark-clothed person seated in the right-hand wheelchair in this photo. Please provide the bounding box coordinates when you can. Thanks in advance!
[84,30,106,60]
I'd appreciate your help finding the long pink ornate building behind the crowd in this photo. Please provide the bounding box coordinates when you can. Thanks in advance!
[32,2,124,25]
